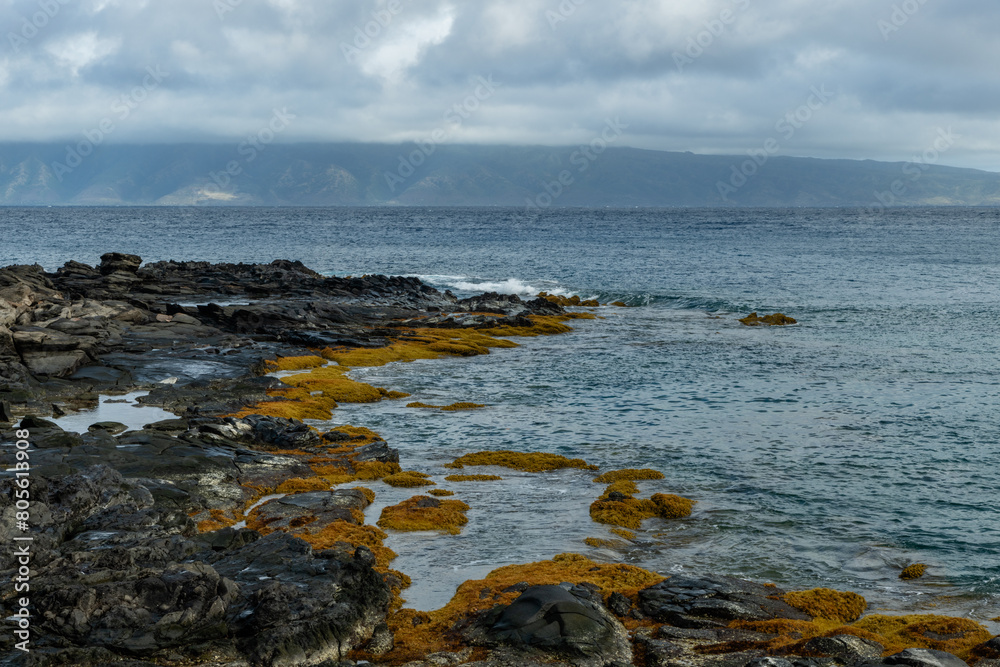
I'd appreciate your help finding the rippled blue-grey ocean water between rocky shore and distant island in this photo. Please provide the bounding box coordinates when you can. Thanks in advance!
[0,208,1000,630]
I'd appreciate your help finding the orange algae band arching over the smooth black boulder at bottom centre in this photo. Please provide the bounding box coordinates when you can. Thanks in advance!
[380,554,664,664]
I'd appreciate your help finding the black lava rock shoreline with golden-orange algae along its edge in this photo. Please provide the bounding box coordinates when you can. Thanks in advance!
[0,253,1000,667]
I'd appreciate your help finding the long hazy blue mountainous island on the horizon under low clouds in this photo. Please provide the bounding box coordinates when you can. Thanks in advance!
[0,140,1000,210]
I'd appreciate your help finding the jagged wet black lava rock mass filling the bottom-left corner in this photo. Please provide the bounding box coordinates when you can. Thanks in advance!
[0,466,389,665]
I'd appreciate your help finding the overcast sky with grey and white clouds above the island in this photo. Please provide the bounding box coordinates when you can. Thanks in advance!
[0,0,1000,171]
